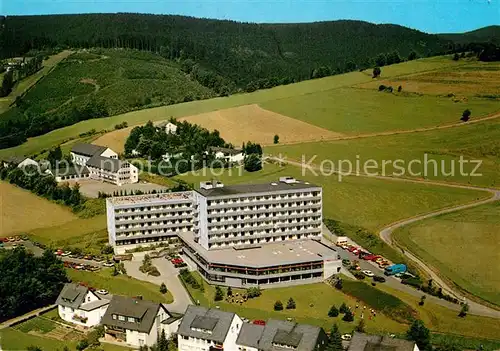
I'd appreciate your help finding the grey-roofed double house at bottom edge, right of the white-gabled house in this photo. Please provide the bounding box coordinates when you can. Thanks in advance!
[236,319,328,351]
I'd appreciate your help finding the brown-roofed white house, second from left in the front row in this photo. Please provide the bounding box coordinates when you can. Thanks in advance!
[101,295,181,347]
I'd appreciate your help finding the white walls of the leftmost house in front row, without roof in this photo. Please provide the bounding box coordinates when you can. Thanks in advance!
[57,290,108,328]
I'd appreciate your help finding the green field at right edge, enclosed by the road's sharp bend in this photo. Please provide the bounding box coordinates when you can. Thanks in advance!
[394,201,500,305]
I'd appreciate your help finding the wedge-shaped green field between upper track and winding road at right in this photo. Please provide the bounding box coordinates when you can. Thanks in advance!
[265,119,500,187]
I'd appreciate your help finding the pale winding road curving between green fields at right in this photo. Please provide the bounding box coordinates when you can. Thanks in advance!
[265,157,500,319]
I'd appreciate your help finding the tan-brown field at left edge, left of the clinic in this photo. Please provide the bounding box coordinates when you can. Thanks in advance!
[0,181,77,236]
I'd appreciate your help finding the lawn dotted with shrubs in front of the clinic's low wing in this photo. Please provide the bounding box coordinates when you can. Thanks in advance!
[182,272,408,333]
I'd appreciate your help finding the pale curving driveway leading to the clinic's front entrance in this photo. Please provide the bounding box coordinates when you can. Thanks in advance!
[124,253,192,314]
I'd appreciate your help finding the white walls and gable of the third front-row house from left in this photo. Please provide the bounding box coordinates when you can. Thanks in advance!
[177,314,243,351]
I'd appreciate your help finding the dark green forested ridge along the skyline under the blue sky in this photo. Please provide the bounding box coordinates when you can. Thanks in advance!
[0,14,448,88]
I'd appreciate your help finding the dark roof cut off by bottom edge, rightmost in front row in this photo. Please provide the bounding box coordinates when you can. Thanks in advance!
[347,333,419,351]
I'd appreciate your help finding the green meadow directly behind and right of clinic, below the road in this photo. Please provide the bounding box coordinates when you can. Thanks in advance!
[174,164,489,230]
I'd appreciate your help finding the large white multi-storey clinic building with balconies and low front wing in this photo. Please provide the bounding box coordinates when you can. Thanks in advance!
[107,177,341,287]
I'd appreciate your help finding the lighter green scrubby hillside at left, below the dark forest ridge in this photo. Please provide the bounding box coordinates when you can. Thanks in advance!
[0,49,215,149]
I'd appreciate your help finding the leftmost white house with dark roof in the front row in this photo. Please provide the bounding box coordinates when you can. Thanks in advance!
[56,283,111,328]
